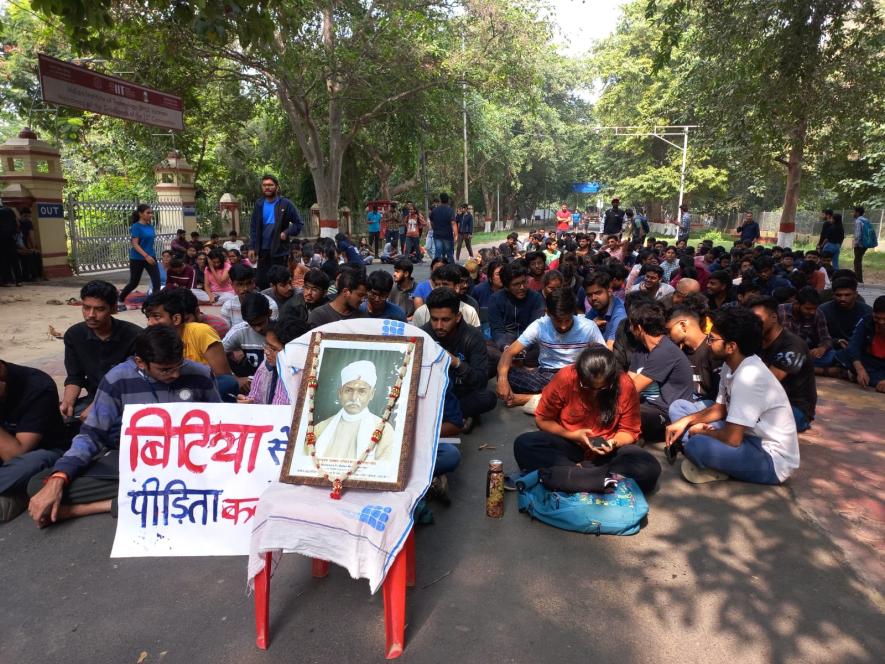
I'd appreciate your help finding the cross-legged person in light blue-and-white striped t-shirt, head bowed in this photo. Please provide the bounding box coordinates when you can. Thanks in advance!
[498,288,605,410]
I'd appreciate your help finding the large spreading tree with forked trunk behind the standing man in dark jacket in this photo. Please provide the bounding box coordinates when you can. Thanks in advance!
[34,0,543,236]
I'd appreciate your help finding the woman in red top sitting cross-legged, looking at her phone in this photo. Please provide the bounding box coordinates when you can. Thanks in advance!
[513,344,661,494]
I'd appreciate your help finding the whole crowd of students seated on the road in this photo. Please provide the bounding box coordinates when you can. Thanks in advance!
[0,223,885,526]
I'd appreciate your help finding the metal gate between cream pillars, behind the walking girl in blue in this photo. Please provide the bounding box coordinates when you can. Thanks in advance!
[67,200,184,274]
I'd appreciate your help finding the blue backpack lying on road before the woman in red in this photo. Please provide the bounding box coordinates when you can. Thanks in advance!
[516,471,648,535]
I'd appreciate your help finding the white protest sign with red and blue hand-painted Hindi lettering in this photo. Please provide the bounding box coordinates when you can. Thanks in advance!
[111,403,292,558]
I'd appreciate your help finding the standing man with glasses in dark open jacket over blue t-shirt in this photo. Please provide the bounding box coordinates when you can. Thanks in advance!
[249,175,304,289]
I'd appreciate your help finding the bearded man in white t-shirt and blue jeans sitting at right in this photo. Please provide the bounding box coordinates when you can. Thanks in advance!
[666,307,799,484]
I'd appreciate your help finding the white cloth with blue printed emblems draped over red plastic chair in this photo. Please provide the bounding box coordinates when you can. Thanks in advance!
[248,318,449,593]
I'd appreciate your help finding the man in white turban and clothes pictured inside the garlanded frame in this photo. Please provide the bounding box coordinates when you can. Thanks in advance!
[314,360,394,461]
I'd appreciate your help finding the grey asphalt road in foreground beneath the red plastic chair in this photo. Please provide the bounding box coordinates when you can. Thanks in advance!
[0,256,885,664]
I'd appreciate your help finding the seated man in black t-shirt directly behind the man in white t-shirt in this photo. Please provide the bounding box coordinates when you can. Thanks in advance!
[748,297,817,433]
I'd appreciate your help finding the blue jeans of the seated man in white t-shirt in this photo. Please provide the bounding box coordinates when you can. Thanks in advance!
[683,434,780,484]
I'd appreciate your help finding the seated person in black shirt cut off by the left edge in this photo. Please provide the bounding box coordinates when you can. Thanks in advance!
[0,360,67,522]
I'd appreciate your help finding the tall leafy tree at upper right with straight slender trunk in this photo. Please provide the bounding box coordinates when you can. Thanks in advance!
[647,0,885,245]
